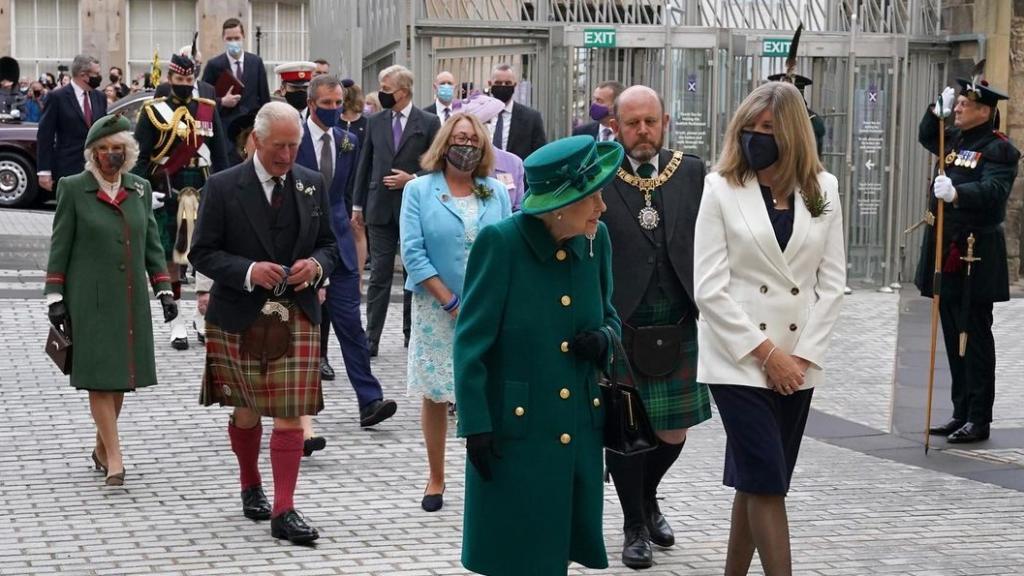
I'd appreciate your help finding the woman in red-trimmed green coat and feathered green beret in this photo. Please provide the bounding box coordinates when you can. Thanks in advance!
[45,116,178,486]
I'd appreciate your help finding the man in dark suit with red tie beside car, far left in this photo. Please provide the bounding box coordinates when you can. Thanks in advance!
[36,54,106,190]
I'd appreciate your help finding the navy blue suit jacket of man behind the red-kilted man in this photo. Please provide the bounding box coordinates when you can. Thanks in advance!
[295,123,359,274]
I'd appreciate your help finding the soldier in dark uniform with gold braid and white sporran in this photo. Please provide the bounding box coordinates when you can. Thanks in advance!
[132,54,227,349]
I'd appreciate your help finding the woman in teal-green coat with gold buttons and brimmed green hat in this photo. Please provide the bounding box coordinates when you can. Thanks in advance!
[455,136,623,576]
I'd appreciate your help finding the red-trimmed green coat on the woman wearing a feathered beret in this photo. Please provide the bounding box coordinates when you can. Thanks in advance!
[45,171,171,392]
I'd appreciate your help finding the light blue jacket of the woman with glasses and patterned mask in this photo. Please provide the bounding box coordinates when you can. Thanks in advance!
[398,172,512,297]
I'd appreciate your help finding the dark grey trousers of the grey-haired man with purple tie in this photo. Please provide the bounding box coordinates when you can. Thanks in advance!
[367,222,413,344]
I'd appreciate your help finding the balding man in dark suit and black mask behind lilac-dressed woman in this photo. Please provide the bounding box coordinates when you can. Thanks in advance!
[487,64,548,160]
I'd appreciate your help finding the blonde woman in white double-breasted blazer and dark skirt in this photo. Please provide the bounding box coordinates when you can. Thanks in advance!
[693,82,846,576]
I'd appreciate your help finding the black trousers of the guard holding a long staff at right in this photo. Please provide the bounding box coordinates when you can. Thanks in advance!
[939,297,995,424]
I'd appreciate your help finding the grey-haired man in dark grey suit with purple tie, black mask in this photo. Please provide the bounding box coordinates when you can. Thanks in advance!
[352,66,441,357]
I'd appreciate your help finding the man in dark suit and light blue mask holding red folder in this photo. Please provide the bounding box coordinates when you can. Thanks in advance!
[203,18,270,164]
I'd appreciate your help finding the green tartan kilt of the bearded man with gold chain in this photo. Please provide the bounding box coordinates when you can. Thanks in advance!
[628,300,711,430]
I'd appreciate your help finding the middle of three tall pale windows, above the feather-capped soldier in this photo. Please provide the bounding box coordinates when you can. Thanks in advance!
[125,0,198,87]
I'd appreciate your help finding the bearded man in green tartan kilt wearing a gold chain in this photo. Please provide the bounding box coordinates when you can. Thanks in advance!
[601,86,711,569]
